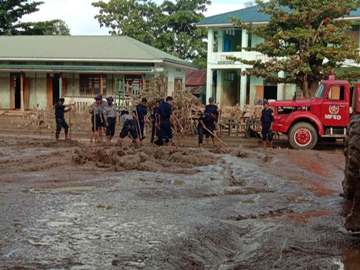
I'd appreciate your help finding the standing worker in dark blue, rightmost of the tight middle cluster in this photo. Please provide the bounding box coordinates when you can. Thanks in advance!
[156,97,175,145]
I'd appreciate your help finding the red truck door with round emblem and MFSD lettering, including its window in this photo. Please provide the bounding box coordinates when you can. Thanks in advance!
[321,85,350,127]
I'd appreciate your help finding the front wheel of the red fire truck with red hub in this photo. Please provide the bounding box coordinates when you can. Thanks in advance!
[289,122,319,150]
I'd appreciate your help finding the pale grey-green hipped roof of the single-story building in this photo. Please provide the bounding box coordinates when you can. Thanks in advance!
[0,36,194,67]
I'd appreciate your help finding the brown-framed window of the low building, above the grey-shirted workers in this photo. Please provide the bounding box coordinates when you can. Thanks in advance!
[80,74,106,96]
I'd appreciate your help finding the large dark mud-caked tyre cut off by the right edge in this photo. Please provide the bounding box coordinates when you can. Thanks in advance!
[343,115,360,231]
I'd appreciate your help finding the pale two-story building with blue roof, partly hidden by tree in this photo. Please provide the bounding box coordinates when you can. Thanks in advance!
[198,6,360,109]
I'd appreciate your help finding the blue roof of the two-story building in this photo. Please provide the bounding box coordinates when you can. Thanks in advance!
[197,5,360,26]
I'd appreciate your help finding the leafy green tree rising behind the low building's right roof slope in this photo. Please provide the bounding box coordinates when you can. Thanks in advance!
[93,0,211,66]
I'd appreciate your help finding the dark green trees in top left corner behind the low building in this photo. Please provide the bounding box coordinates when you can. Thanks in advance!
[0,0,70,35]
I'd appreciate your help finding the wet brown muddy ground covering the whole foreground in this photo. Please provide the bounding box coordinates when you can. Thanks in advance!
[0,115,360,270]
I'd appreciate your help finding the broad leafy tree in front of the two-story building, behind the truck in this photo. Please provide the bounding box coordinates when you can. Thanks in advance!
[232,0,360,97]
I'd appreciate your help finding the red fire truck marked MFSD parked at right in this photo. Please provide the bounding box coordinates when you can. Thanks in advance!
[270,72,360,149]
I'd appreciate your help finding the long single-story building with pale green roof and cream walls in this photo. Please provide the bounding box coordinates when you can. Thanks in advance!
[0,36,197,111]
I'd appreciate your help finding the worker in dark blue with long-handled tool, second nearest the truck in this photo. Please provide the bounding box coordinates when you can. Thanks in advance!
[199,111,218,147]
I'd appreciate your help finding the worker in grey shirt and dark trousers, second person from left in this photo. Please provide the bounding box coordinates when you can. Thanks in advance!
[89,95,107,143]
